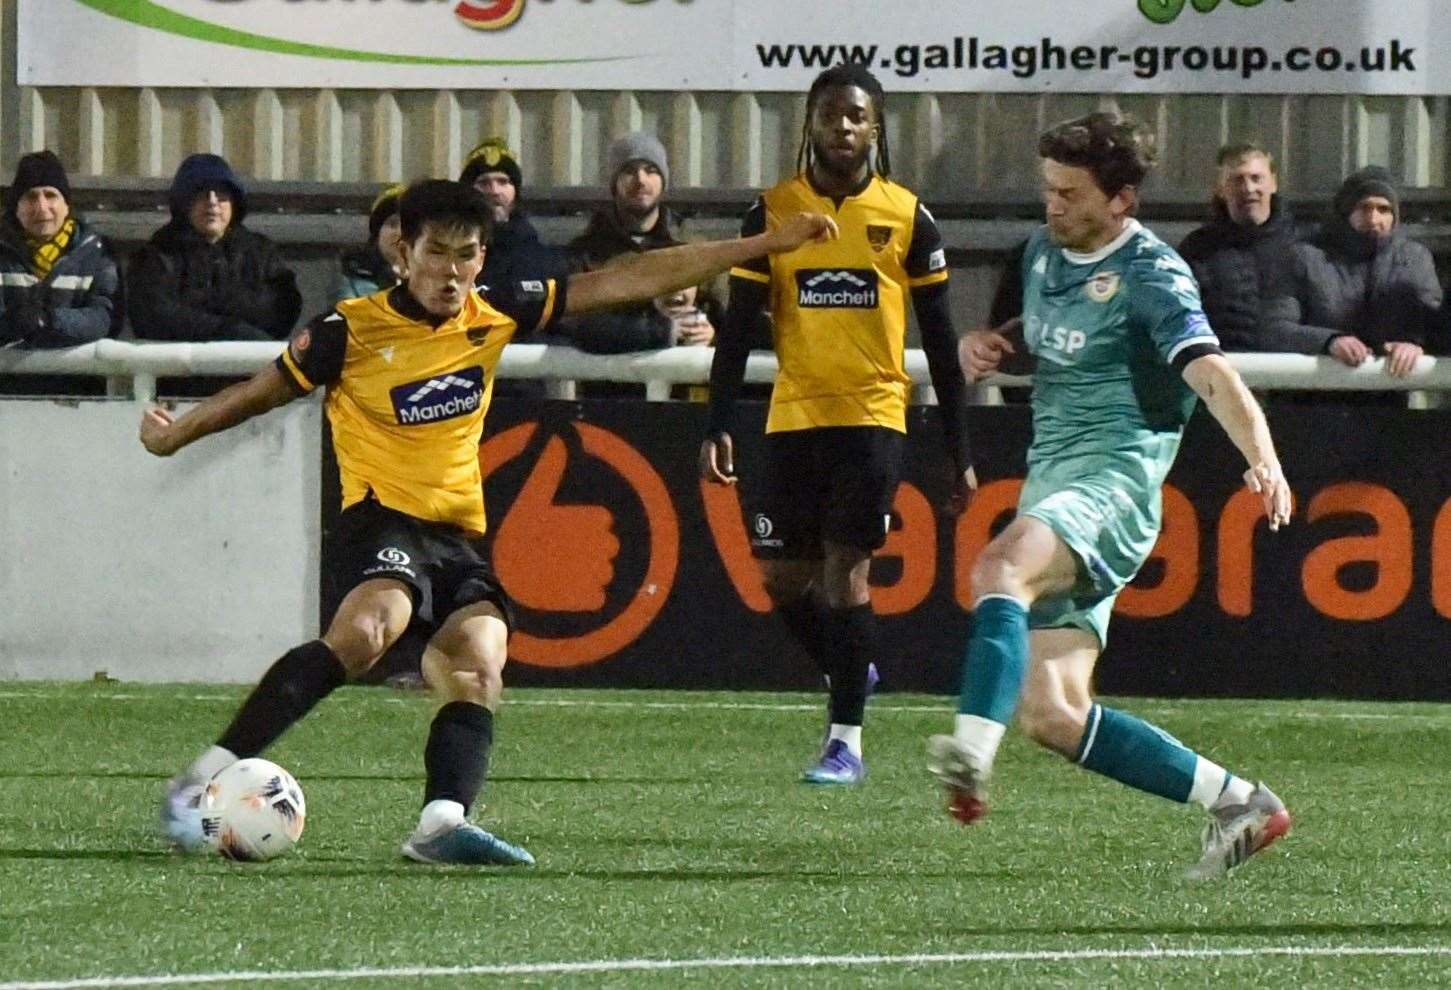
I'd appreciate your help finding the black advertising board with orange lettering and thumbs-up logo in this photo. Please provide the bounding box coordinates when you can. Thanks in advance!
[336,399,1451,700]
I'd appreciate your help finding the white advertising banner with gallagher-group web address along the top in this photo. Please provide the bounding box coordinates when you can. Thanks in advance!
[19,0,1451,94]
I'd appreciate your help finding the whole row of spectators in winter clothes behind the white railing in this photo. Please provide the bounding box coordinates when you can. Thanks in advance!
[0,132,1451,391]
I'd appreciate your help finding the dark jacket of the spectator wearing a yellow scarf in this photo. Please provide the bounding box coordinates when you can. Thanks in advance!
[0,216,125,348]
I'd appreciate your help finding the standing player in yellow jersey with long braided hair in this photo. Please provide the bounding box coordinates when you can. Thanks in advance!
[701,64,977,784]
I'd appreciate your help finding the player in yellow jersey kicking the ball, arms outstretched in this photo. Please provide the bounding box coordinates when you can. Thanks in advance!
[141,180,834,865]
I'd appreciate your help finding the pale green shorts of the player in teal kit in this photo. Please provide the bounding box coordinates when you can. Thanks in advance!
[1017,472,1164,647]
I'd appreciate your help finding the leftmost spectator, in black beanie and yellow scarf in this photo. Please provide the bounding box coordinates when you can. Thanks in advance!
[0,151,123,352]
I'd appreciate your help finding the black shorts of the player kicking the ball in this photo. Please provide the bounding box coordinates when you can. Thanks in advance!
[325,498,514,630]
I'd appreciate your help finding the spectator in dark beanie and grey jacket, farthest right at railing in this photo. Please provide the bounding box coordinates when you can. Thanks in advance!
[1294,165,1441,377]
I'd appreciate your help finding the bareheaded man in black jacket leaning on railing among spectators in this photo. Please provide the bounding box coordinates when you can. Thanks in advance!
[1180,142,1332,354]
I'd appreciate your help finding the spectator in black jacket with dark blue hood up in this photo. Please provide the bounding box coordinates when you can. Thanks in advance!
[126,154,302,341]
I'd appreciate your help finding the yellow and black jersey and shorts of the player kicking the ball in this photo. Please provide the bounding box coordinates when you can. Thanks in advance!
[277,279,564,624]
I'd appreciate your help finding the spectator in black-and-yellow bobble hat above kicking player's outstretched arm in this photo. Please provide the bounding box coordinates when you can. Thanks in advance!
[459,138,569,286]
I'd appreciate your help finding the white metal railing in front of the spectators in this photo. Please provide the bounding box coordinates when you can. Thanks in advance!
[0,340,1451,401]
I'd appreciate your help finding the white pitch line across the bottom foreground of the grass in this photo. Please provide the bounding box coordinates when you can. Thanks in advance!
[0,945,1451,990]
